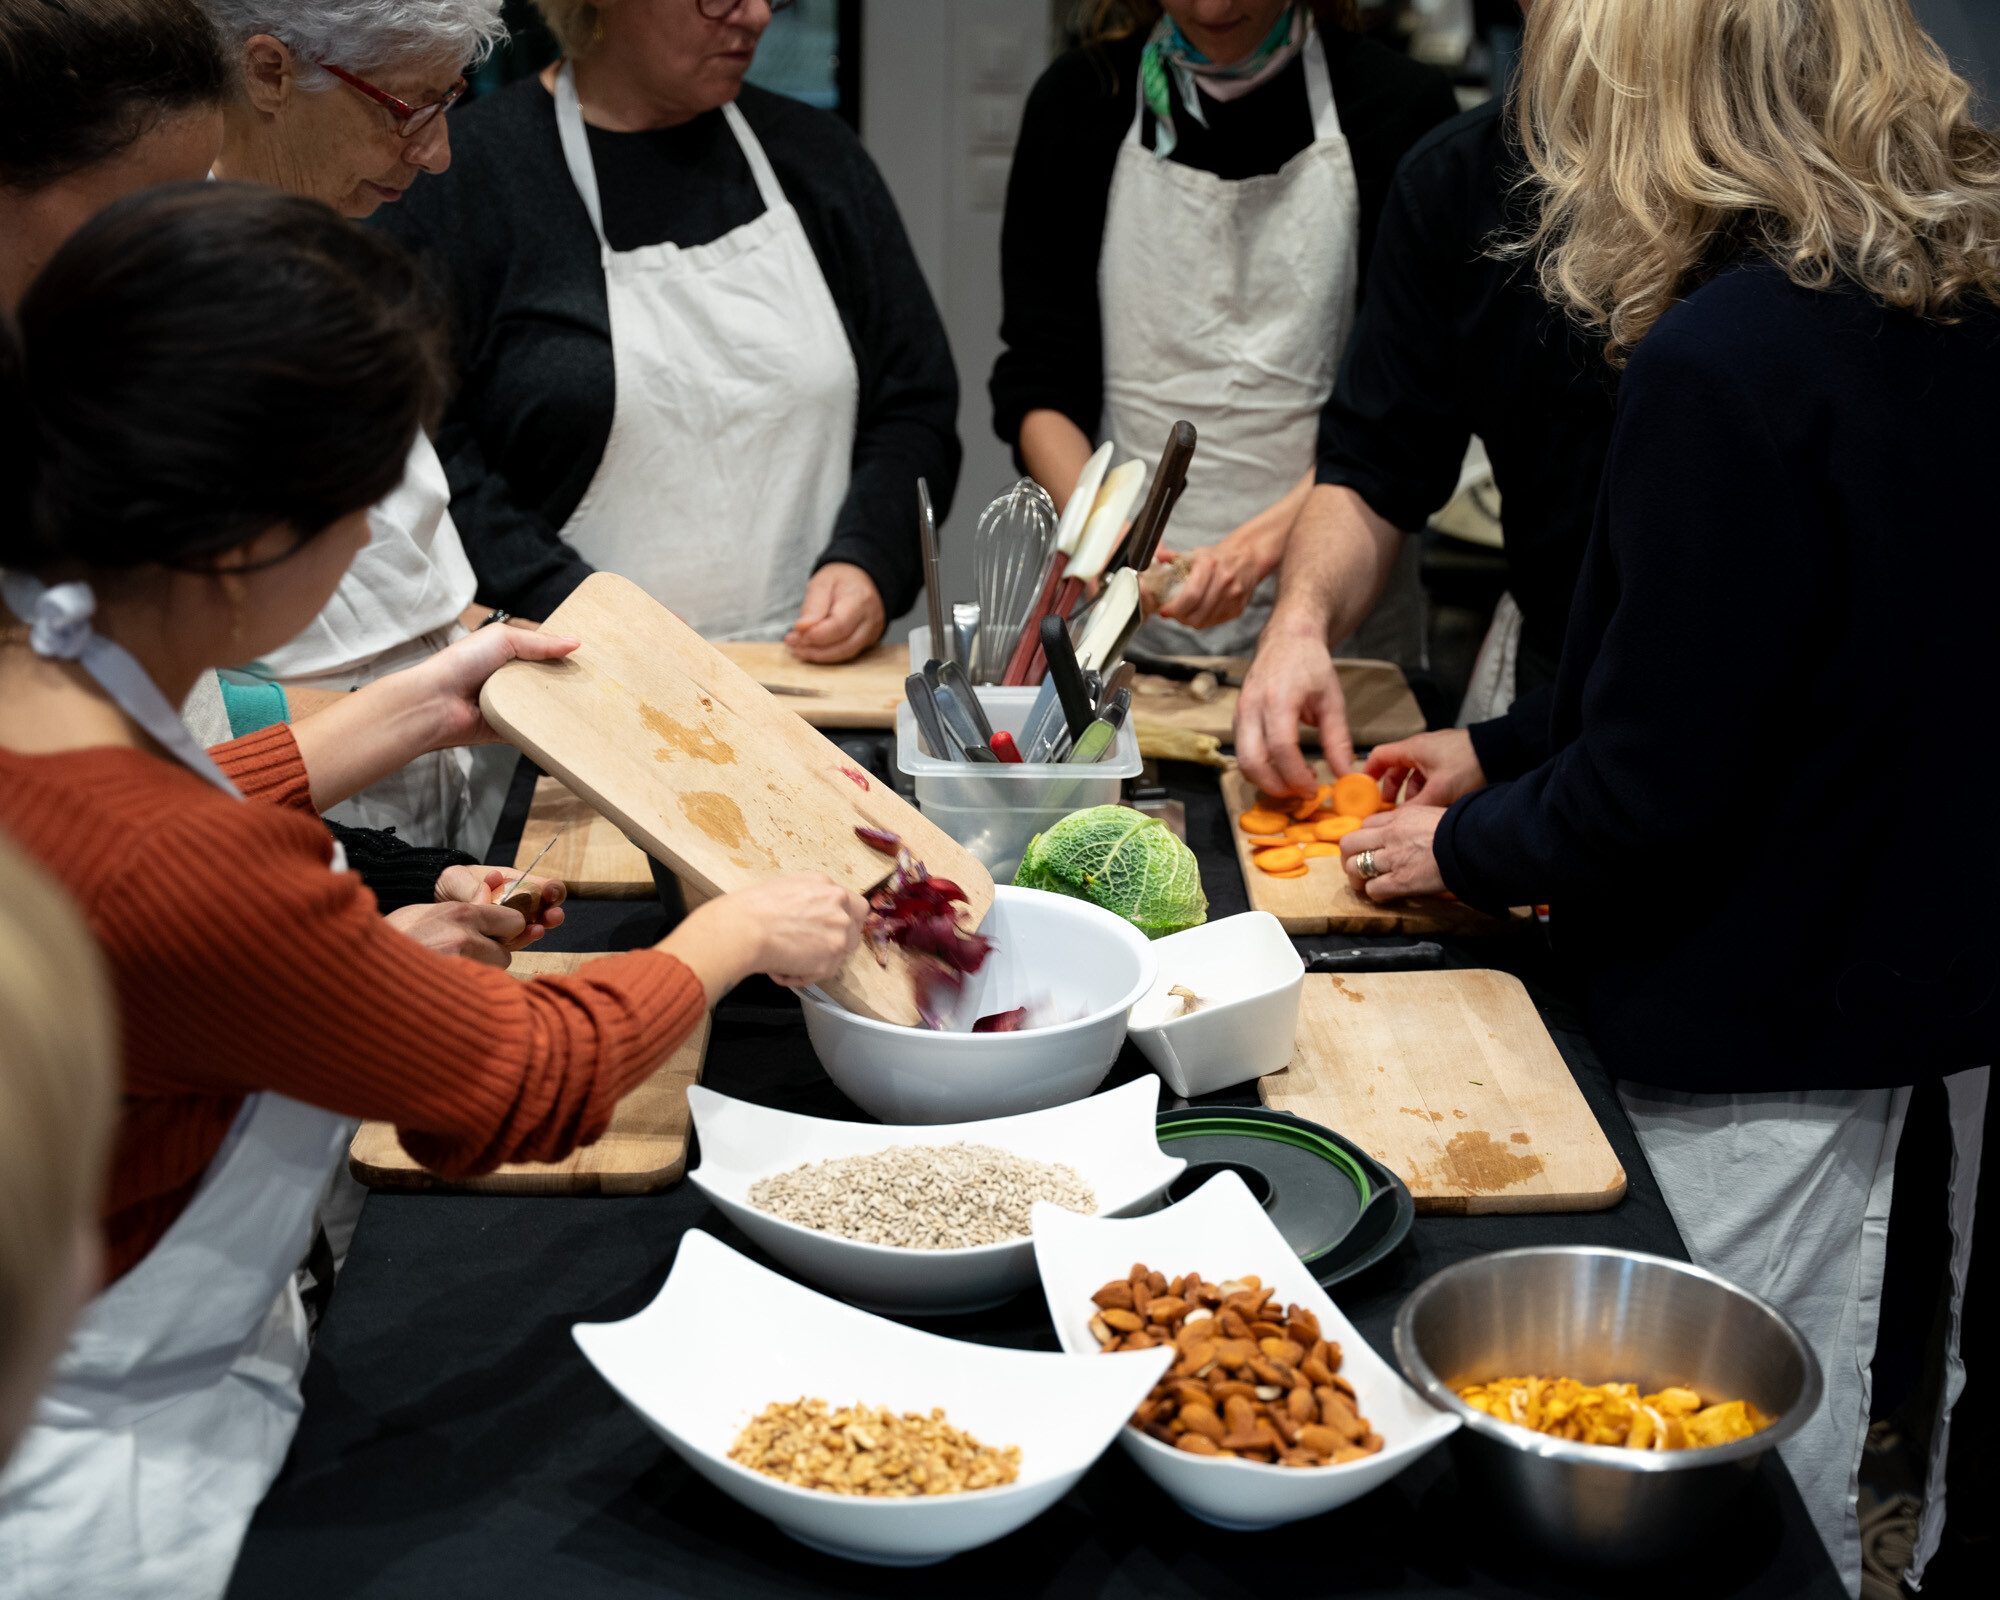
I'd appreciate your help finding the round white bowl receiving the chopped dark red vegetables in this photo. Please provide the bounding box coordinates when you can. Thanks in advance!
[800,888,1156,1122]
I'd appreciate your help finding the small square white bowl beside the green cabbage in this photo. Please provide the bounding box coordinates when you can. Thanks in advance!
[1128,912,1306,1098]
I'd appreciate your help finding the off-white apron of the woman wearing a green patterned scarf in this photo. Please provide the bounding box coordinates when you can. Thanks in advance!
[1098,36,1360,656]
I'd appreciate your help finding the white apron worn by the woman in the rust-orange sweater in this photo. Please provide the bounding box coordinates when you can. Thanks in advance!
[0,574,354,1600]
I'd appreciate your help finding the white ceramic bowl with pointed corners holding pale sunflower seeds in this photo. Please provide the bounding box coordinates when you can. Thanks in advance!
[688,1076,1186,1314]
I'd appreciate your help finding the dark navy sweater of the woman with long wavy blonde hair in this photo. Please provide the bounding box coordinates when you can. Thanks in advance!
[1436,262,2000,1092]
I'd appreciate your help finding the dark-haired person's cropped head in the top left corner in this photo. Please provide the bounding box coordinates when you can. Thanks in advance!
[0,0,228,308]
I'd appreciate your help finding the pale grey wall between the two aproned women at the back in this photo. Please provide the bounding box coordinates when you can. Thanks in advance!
[862,0,1050,624]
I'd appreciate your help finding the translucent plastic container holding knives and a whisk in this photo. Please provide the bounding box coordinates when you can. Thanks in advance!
[896,688,1144,884]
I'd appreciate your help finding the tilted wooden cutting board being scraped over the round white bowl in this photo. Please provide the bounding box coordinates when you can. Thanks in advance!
[480,572,994,1026]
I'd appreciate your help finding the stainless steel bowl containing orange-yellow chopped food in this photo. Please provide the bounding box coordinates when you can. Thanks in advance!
[1396,1246,1820,1566]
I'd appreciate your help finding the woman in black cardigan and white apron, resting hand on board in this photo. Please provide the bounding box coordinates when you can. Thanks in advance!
[382,0,958,662]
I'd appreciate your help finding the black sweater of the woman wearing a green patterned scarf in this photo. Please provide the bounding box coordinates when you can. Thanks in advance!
[992,32,1458,456]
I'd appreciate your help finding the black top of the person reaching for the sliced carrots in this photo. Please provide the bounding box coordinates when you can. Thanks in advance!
[1320,102,1616,664]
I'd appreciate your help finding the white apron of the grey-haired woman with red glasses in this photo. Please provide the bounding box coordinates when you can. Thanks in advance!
[258,432,494,856]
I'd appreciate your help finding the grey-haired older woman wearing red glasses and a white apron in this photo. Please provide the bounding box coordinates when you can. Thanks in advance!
[202,0,508,854]
